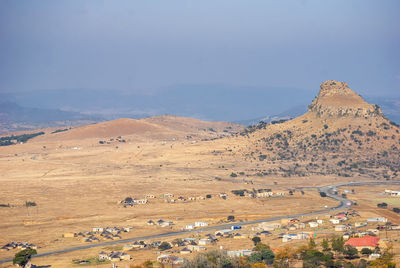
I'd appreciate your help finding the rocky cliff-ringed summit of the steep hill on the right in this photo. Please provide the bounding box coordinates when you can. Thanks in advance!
[309,80,382,117]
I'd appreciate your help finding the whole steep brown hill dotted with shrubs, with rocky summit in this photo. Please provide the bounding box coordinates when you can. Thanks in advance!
[234,81,400,179]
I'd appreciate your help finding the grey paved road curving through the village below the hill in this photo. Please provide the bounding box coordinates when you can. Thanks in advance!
[0,181,400,263]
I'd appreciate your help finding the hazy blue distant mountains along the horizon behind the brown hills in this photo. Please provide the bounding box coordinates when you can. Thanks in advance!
[0,85,400,133]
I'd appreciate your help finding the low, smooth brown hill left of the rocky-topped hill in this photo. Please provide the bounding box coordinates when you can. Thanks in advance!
[28,116,243,142]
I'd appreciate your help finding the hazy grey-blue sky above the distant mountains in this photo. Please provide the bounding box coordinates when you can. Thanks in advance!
[0,0,400,95]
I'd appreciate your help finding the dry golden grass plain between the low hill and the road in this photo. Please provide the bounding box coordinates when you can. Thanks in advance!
[0,129,350,266]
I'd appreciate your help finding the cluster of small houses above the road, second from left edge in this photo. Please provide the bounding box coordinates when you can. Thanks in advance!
[63,227,133,243]
